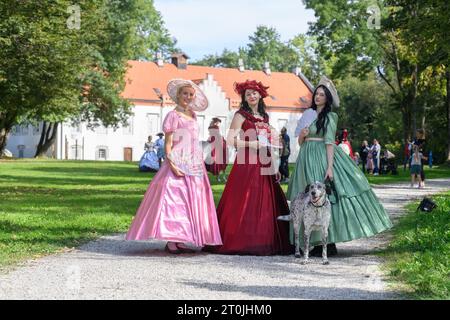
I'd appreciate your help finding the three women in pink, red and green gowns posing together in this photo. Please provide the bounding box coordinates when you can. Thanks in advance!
[126,77,392,255]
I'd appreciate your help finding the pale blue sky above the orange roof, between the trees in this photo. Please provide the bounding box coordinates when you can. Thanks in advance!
[154,0,315,61]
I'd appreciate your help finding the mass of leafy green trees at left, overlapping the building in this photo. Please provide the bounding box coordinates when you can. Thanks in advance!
[0,0,174,156]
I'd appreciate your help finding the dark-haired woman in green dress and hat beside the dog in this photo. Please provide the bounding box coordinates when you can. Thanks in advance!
[287,77,392,255]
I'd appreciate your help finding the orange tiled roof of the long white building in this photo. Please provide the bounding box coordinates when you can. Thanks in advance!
[123,57,312,113]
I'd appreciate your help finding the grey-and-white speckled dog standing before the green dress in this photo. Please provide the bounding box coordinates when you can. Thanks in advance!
[279,181,331,264]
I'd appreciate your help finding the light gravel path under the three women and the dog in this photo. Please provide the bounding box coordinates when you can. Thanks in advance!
[0,179,450,300]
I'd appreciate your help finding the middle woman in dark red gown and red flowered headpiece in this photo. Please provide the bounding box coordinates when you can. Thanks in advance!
[212,80,292,255]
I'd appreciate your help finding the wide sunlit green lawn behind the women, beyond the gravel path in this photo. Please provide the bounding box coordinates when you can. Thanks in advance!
[0,160,450,276]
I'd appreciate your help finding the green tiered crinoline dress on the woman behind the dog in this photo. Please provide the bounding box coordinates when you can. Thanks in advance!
[287,112,392,245]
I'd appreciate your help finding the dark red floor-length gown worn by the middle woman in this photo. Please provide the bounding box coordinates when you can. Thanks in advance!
[211,109,293,255]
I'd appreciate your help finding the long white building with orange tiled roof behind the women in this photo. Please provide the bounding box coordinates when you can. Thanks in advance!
[7,54,313,161]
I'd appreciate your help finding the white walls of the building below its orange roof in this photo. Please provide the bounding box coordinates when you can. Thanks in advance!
[6,57,312,162]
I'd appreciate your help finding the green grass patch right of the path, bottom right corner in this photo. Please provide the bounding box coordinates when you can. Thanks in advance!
[381,191,450,300]
